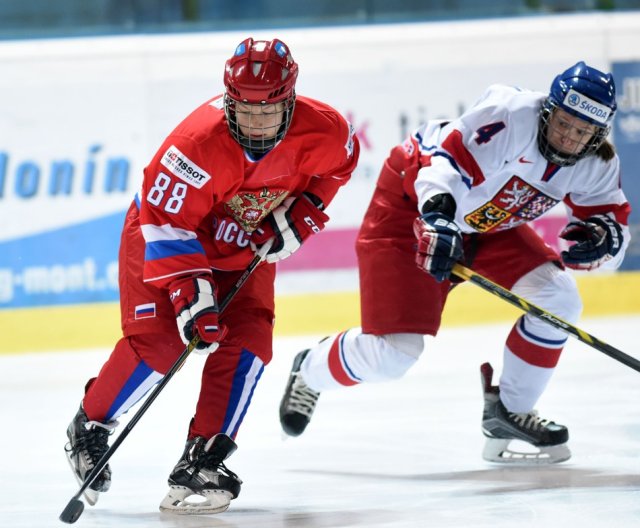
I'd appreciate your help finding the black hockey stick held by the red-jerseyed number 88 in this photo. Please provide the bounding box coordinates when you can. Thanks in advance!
[60,241,273,524]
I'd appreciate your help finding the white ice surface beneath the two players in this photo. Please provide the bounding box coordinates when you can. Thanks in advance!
[0,316,640,528]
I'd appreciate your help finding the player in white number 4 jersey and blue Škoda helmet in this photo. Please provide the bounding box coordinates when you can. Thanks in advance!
[280,62,630,463]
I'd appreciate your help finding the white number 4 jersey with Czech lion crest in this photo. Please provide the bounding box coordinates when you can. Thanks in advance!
[414,85,630,266]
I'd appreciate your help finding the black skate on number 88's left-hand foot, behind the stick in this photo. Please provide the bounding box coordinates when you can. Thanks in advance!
[64,405,118,506]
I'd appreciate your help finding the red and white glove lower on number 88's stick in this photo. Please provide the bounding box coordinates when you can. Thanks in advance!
[169,275,227,354]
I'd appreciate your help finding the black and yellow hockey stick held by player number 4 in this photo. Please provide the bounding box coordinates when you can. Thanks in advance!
[453,264,640,372]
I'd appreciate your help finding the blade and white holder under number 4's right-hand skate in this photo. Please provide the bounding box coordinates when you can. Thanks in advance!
[482,438,571,466]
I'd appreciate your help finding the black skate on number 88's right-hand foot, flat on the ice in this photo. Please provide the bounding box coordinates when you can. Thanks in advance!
[160,434,242,515]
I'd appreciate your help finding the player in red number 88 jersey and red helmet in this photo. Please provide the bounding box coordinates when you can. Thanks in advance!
[65,38,359,513]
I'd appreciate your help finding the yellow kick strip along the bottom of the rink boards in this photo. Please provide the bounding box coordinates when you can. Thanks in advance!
[0,272,640,354]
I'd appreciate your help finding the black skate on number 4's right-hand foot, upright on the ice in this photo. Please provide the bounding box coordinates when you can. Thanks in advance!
[480,363,571,465]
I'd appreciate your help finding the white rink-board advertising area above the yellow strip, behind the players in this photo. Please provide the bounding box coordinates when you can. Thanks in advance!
[0,19,640,316]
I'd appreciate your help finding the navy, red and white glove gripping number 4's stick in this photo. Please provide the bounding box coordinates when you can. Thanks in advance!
[413,213,463,282]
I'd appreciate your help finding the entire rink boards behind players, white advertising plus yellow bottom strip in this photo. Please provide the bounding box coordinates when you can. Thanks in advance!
[0,13,640,354]
